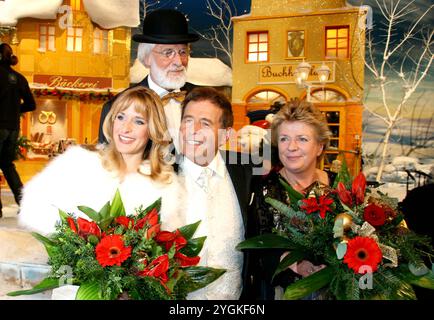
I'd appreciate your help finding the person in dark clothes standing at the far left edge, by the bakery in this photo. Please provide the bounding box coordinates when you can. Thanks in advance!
[0,43,36,217]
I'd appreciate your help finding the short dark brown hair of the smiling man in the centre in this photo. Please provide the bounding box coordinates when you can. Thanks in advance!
[181,87,234,129]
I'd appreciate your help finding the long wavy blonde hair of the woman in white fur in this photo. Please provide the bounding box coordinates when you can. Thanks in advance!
[100,86,173,183]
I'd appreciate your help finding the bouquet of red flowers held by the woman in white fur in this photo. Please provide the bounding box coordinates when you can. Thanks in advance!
[9,192,225,300]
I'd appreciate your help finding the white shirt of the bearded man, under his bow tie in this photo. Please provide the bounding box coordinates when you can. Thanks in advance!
[148,76,182,150]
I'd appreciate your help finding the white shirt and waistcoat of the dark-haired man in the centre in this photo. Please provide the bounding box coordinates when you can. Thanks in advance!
[180,153,244,300]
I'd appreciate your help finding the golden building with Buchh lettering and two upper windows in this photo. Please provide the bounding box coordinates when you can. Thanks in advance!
[232,0,366,173]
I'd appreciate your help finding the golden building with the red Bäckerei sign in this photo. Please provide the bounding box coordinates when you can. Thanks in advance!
[2,0,131,155]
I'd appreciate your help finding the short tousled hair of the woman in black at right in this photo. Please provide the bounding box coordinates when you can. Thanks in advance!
[271,99,331,159]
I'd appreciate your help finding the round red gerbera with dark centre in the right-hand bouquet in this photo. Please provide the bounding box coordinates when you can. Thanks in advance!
[344,237,383,274]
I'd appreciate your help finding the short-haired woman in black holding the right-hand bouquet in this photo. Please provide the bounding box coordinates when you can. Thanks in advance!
[246,100,332,300]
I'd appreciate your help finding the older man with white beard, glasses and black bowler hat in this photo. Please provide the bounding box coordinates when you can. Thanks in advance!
[98,9,199,147]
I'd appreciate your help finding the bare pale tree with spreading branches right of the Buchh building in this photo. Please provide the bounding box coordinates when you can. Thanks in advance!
[365,0,434,181]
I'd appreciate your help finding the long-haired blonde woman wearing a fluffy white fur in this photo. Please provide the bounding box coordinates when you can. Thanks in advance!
[19,87,184,234]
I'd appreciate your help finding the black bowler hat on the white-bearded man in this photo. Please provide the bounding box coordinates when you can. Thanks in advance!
[133,9,199,44]
